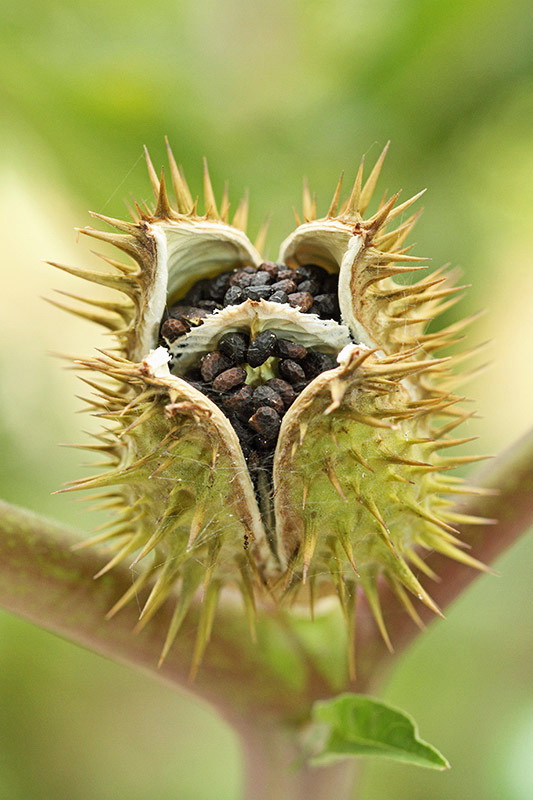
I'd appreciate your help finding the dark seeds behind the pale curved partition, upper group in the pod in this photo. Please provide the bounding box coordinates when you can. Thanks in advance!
[161,261,340,344]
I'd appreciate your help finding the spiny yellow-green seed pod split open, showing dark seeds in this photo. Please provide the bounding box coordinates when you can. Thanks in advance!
[54,143,490,673]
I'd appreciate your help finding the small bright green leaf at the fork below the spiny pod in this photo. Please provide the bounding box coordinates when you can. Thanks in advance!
[307,694,450,769]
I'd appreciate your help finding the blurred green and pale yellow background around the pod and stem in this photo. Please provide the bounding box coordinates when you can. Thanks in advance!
[0,0,533,800]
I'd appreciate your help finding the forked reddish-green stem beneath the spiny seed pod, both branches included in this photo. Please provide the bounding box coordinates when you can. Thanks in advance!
[0,424,533,800]
